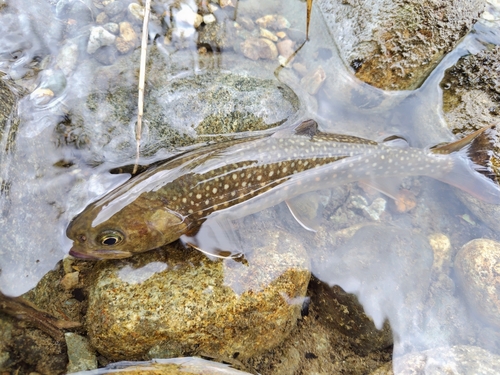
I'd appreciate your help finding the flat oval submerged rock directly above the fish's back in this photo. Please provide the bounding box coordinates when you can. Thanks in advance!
[57,47,299,161]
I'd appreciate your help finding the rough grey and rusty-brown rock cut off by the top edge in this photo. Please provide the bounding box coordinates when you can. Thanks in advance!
[318,0,485,90]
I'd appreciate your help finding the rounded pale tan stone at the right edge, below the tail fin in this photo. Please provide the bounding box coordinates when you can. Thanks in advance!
[455,238,500,328]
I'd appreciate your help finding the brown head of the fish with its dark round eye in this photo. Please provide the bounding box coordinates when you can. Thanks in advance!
[66,202,187,260]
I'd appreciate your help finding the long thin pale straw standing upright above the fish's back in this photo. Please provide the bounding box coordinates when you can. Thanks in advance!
[133,0,151,174]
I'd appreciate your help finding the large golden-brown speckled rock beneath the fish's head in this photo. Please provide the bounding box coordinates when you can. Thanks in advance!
[87,233,310,360]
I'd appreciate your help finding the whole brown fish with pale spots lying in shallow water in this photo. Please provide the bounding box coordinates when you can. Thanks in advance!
[66,120,500,259]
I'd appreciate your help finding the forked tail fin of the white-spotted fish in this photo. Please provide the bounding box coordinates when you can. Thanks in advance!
[431,125,500,204]
